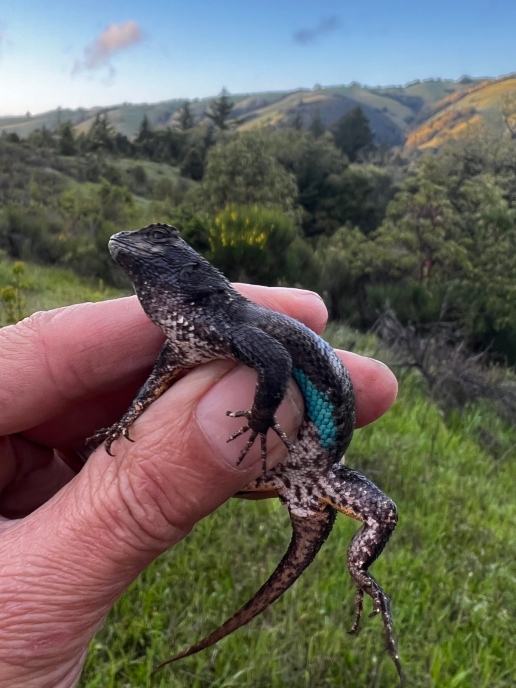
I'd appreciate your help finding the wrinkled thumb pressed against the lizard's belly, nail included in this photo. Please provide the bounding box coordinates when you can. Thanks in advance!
[0,361,302,686]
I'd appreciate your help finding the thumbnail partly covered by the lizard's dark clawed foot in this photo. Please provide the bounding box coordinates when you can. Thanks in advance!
[196,366,303,468]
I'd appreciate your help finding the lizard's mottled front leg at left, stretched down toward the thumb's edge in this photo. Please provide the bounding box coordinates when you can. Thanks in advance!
[86,340,185,456]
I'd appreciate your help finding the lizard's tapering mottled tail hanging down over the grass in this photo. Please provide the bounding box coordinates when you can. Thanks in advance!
[155,506,336,671]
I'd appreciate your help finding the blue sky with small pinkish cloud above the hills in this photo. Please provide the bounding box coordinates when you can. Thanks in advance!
[0,0,516,115]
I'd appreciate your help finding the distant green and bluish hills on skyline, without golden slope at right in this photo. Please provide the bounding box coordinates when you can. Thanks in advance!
[0,77,488,145]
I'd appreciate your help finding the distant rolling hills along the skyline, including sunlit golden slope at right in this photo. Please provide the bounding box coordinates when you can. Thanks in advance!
[0,76,516,151]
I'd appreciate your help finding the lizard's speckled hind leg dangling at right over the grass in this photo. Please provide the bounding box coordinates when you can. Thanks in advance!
[318,463,404,683]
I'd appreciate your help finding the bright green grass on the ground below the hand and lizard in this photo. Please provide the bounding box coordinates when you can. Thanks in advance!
[72,328,516,688]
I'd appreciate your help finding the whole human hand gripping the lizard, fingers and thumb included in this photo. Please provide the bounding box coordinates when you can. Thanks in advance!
[0,285,397,688]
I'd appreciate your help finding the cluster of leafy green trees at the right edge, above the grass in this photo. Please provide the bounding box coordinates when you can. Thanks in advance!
[330,139,516,362]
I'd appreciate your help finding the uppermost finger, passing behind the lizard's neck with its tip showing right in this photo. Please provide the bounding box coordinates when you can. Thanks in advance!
[0,285,326,435]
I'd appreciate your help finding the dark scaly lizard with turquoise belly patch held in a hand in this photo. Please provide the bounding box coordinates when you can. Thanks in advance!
[88,223,404,683]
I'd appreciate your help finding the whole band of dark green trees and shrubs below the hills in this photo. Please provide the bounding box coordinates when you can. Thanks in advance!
[0,107,516,362]
